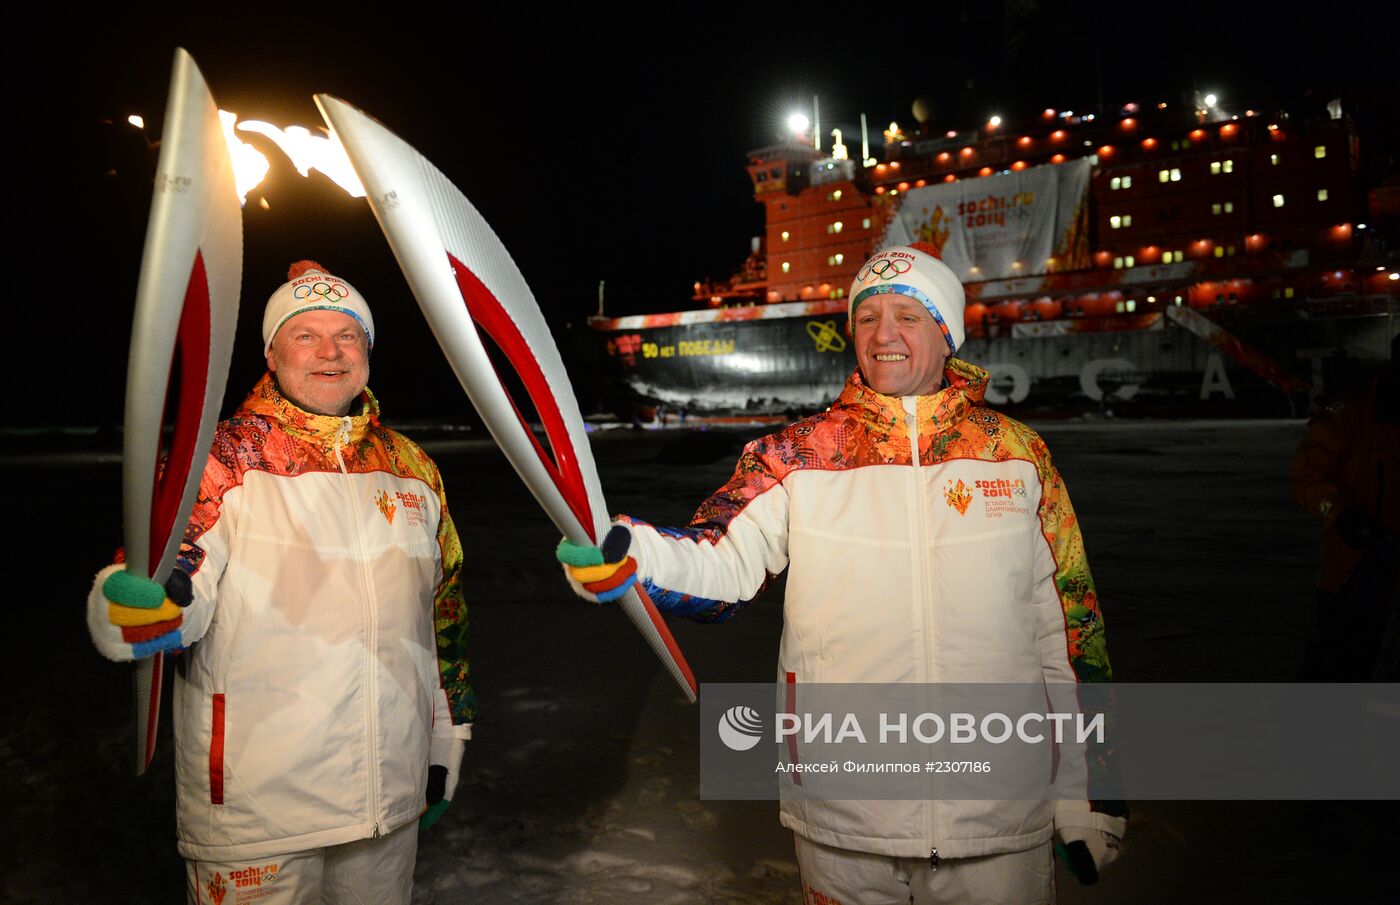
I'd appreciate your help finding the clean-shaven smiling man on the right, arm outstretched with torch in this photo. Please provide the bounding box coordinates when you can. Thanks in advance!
[559,245,1126,905]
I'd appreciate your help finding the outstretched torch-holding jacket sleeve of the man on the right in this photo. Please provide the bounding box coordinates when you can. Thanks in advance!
[617,440,788,622]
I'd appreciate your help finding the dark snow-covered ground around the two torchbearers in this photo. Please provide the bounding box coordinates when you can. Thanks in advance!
[0,422,1400,905]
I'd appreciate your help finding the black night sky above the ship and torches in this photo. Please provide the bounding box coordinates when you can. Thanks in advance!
[6,7,1397,424]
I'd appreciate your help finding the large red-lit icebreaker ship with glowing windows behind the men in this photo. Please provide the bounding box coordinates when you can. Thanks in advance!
[594,92,1400,412]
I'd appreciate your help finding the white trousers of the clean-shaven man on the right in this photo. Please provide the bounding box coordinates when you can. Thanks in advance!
[792,834,1054,905]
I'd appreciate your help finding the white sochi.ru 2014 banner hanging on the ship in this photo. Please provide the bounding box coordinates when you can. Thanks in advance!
[883,160,1089,282]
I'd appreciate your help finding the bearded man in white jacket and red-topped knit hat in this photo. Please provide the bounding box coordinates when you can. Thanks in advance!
[88,261,476,905]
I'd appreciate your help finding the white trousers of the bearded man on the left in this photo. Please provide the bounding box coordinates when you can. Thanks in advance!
[185,821,419,905]
